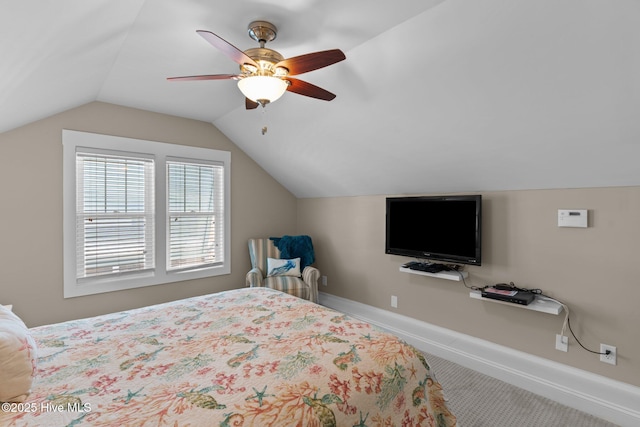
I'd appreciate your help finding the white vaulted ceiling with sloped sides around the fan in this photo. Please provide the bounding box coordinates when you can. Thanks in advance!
[0,0,640,197]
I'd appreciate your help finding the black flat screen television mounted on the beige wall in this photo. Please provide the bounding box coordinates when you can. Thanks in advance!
[385,195,482,265]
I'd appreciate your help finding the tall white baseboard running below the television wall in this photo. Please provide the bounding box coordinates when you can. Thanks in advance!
[320,292,640,426]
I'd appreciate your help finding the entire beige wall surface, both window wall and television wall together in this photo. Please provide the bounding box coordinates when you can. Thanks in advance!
[0,102,640,386]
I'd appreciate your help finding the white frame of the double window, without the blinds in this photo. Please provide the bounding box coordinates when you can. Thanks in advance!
[62,129,231,298]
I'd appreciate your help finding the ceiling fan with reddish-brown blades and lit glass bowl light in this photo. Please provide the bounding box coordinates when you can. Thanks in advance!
[167,21,346,110]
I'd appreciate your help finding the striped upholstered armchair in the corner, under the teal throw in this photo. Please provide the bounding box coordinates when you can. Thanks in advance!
[246,236,320,303]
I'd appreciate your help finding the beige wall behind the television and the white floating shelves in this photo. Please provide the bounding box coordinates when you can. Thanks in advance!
[298,191,640,386]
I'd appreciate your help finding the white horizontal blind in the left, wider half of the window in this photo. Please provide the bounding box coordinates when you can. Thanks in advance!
[76,151,154,280]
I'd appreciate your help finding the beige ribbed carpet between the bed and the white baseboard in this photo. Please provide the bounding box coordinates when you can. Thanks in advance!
[426,354,615,427]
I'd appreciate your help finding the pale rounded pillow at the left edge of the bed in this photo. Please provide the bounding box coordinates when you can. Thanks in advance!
[0,305,37,402]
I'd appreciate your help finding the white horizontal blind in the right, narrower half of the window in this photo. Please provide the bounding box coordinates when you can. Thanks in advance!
[167,159,225,271]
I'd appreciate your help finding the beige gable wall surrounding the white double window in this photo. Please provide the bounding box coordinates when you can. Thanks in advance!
[0,102,296,326]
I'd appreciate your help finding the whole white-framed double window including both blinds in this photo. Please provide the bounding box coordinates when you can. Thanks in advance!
[63,130,231,298]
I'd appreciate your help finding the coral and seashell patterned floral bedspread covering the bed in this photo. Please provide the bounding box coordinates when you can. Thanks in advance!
[0,288,456,427]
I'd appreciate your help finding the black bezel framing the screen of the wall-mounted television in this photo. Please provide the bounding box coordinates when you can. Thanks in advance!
[385,194,482,265]
